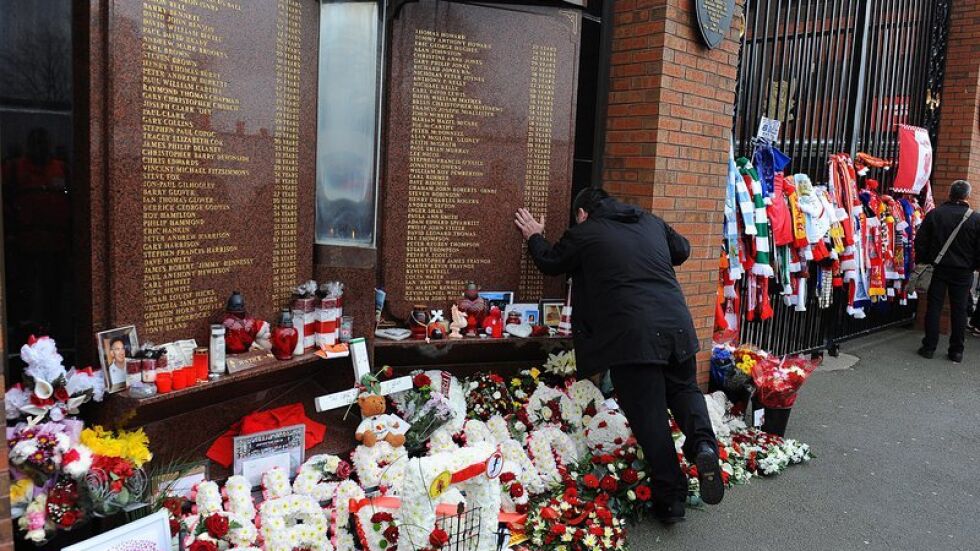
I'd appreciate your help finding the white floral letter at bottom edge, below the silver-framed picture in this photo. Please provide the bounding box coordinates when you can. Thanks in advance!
[259,494,333,551]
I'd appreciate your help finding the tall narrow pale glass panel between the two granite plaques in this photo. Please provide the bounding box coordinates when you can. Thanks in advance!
[316,2,383,247]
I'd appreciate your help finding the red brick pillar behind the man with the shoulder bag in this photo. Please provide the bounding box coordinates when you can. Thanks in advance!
[918,0,980,334]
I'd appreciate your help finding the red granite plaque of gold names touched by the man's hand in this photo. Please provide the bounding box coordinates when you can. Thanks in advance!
[382,0,581,318]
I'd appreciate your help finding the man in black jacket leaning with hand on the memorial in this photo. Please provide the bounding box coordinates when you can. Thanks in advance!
[515,188,725,523]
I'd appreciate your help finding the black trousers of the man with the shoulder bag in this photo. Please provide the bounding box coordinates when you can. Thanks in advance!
[922,266,973,354]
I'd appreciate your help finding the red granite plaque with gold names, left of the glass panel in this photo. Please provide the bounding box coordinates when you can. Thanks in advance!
[106,0,319,343]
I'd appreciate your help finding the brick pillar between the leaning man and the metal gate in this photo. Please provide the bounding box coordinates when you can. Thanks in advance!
[603,0,741,383]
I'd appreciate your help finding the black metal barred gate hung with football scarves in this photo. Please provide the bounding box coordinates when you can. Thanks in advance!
[733,0,950,354]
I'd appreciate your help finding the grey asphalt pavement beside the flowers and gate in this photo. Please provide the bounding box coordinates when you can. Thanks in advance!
[629,330,980,551]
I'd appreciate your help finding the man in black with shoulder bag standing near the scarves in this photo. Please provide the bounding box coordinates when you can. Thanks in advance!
[915,180,980,363]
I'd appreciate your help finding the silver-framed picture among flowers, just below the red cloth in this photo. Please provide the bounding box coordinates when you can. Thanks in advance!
[232,425,306,488]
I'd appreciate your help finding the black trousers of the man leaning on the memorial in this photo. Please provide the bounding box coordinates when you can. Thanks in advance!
[610,357,717,504]
